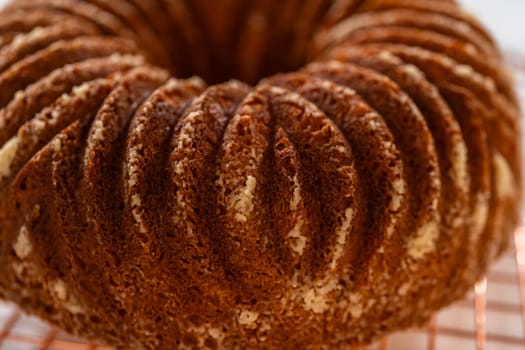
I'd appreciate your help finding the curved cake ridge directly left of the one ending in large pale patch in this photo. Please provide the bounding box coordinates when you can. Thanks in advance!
[265,74,407,278]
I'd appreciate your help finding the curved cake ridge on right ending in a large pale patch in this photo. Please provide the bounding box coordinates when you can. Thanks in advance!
[305,62,442,336]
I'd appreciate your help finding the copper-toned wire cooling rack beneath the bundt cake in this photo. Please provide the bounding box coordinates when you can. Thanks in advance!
[0,54,525,350]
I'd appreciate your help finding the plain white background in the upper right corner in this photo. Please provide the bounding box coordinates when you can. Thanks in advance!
[0,0,525,53]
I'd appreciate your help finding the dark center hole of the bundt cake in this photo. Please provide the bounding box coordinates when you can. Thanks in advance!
[157,15,310,85]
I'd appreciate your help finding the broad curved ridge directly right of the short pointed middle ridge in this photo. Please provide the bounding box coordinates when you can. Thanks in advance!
[262,87,362,276]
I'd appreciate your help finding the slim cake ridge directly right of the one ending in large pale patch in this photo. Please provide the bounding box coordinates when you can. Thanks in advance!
[336,47,470,300]
